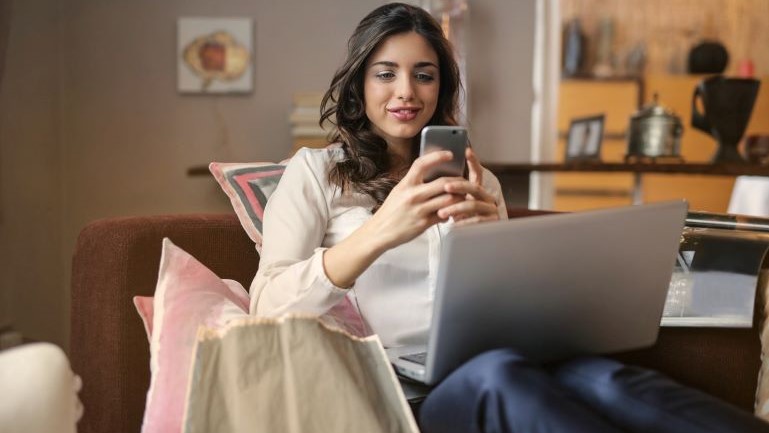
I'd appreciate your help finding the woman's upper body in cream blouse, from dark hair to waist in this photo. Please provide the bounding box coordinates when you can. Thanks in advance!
[251,0,506,346]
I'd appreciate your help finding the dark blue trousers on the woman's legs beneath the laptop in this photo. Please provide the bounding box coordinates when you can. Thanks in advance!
[419,349,769,433]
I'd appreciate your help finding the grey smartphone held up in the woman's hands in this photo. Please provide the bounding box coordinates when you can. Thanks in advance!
[419,125,467,182]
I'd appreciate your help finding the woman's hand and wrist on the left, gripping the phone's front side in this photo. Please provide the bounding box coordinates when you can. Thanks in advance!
[365,151,465,250]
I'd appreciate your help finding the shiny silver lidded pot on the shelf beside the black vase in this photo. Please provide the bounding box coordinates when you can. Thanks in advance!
[625,93,684,160]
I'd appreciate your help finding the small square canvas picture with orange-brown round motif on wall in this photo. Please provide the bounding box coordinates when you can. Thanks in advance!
[177,18,254,93]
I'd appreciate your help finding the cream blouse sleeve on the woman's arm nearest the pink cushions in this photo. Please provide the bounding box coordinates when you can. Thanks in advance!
[250,149,347,316]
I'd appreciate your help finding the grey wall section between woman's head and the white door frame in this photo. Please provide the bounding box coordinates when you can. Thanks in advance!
[467,0,536,162]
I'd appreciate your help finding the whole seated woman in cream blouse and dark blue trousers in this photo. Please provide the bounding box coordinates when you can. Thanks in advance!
[251,3,766,432]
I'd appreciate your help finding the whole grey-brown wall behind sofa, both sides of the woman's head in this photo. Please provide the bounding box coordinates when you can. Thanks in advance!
[0,0,534,347]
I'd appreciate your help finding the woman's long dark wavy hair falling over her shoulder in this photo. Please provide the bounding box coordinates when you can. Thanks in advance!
[320,3,462,212]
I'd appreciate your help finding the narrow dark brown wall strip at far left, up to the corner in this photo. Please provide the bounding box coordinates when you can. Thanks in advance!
[0,0,61,342]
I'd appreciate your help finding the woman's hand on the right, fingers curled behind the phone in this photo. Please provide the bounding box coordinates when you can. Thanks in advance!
[438,147,499,225]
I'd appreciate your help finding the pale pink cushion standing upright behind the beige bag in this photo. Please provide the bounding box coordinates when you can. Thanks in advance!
[134,238,249,433]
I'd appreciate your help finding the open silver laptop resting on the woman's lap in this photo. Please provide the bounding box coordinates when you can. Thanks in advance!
[387,201,687,385]
